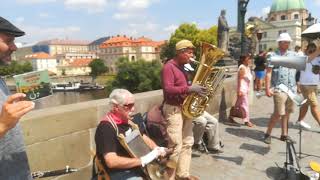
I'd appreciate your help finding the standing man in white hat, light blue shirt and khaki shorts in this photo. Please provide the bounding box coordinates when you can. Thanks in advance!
[264,33,297,144]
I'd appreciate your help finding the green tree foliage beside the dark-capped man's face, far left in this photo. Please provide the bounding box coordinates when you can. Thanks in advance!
[0,61,32,76]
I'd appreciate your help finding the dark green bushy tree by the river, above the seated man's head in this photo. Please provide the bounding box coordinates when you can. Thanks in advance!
[106,58,162,93]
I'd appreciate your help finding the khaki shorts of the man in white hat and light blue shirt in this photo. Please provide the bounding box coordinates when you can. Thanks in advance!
[273,92,294,116]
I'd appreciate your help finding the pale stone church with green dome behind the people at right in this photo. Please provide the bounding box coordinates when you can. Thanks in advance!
[252,0,309,51]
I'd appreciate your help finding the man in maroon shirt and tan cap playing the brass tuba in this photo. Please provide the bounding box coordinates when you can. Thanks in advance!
[161,40,206,180]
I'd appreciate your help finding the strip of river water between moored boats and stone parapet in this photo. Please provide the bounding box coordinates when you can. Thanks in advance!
[34,90,107,109]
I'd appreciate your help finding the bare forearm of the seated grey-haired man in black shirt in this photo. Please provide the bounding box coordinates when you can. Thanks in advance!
[104,152,141,169]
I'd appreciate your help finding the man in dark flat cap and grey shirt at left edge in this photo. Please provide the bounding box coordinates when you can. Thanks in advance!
[0,17,34,180]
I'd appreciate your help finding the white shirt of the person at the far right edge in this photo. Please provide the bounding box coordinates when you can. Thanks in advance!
[300,56,320,85]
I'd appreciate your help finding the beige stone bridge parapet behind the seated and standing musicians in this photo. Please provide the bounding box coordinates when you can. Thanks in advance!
[21,78,236,180]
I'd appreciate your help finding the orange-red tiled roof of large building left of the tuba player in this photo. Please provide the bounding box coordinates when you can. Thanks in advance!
[100,36,164,48]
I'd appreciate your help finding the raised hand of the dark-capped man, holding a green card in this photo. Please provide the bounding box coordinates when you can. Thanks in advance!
[0,93,34,138]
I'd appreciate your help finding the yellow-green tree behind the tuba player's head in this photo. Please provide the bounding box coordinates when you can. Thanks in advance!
[160,23,217,60]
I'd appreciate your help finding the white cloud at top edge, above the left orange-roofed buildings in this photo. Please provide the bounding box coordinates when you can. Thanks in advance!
[64,0,107,13]
